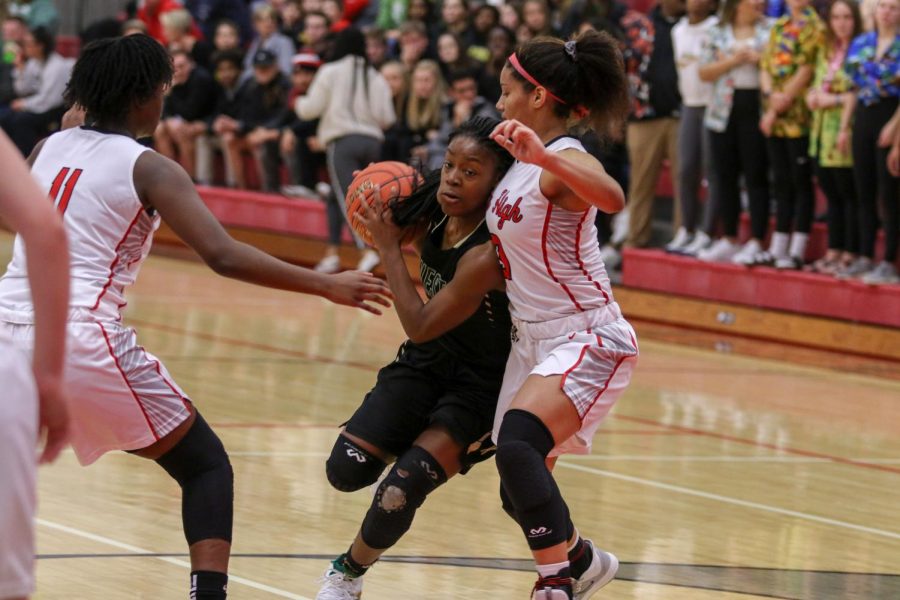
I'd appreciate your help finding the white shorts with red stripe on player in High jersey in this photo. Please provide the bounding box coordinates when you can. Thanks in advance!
[493,302,638,456]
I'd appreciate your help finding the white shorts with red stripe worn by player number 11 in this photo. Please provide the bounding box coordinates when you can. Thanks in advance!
[3,321,191,465]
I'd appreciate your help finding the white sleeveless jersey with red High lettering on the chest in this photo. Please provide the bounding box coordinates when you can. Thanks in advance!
[487,136,613,322]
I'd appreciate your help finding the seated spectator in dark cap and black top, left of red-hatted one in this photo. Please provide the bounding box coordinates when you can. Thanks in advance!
[222,48,293,192]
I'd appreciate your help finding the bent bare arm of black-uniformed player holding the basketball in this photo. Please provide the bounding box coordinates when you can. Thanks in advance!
[359,192,504,343]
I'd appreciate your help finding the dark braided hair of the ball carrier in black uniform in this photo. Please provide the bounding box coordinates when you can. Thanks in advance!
[391,117,515,227]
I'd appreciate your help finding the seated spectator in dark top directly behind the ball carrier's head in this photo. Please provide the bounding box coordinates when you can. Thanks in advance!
[428,69,500,170]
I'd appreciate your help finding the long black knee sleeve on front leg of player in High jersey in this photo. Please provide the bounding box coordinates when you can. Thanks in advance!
[496,409,569,550]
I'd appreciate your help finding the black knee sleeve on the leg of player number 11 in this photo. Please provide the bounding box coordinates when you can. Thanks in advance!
[156,413,234,545]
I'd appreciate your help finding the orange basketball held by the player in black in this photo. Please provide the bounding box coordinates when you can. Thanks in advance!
[346,160,423,246]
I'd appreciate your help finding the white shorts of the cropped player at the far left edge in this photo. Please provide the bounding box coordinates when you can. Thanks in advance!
[0,331,38,598]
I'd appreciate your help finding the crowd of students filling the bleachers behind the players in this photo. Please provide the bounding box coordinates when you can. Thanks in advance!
[0,0,900,283]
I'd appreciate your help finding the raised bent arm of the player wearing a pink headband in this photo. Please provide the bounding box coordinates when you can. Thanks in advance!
[491,120,625,213]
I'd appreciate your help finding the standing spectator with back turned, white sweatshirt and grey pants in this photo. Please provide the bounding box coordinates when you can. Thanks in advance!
[296,27,396,272]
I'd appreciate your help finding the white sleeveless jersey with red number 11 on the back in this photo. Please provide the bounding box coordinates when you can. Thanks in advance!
[0,127,160,324]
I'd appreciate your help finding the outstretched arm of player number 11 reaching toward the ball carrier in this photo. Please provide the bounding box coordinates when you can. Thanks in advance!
[134,152,390,315]
